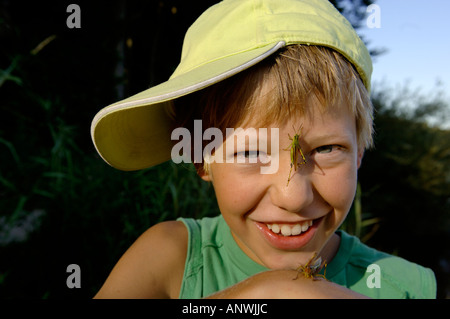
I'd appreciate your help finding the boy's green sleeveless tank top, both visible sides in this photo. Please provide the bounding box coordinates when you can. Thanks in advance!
[179,216,436,299]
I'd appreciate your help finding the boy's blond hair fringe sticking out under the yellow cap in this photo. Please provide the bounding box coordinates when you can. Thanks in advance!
[175,44,373,173]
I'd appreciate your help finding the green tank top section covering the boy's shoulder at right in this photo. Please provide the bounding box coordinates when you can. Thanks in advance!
[327,232,436,298]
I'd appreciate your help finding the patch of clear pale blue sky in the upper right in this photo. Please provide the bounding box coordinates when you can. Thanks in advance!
[358,0,450,96]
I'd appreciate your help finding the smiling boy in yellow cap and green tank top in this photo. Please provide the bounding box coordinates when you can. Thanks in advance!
[92,0,436,298]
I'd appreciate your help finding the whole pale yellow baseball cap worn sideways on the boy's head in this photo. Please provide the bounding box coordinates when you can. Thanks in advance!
[91,0,372,171]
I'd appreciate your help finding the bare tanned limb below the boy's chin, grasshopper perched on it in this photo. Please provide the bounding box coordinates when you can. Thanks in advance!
[208,270,367,299]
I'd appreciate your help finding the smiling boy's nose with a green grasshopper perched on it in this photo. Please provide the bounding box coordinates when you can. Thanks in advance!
[271,159,314,213]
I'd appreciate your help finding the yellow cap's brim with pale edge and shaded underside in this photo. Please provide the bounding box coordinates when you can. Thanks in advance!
[91,41,286,171]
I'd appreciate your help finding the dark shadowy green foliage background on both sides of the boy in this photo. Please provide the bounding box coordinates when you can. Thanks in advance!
[0,0,450,299]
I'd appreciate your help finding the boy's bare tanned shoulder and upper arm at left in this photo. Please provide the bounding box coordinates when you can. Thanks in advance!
[95,221,188,299]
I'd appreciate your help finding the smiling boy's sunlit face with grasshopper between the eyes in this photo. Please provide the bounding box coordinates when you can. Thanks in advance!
[202,97,362,269]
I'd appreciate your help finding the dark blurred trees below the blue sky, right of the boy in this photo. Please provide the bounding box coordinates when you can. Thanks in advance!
[359,87,450,295]
